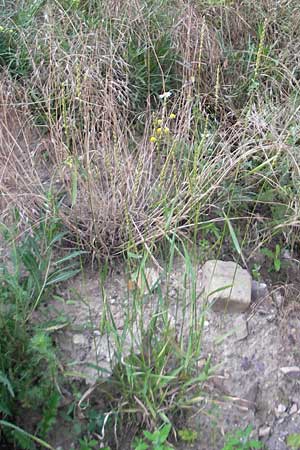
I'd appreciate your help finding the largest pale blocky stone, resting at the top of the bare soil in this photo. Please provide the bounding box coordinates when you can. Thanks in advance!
[202,260,251,313]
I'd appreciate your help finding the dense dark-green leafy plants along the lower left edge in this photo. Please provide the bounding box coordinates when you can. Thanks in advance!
[0,212,82,449]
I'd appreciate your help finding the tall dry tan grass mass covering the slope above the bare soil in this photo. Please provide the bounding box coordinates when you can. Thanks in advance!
[0,0,299,255]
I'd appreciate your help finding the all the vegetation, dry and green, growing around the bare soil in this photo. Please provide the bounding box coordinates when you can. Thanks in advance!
[0,0,300,450]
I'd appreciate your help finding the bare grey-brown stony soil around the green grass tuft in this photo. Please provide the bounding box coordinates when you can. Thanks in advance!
[44,253,300,450]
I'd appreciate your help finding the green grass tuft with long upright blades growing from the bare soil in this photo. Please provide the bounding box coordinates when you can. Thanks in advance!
[85,239,214,448]
